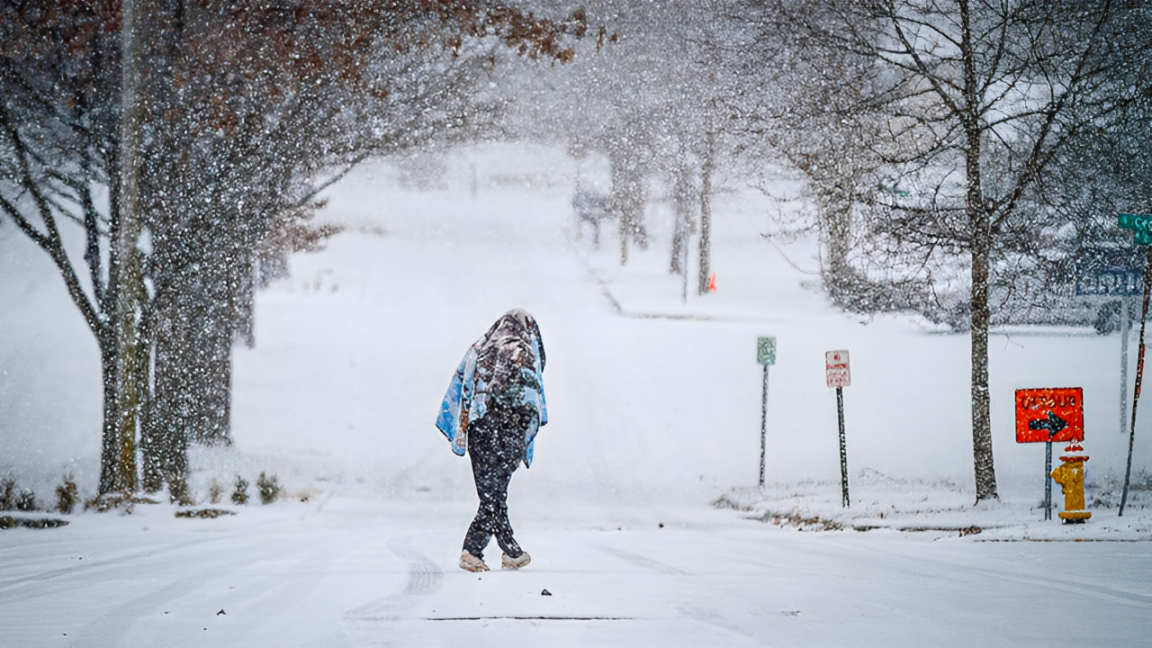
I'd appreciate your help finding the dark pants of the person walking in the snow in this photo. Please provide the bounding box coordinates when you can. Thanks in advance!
[464,408,526,558]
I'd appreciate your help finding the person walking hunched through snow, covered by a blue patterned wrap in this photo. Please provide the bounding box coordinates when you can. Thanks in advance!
[435,308,548,572]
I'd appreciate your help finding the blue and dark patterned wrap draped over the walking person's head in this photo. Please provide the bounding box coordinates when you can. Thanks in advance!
[435,309,548,467]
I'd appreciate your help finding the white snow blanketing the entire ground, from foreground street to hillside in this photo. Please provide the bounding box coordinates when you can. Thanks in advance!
[0,146,1152,647]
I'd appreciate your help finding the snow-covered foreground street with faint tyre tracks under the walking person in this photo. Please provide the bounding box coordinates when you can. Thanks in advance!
[0,491,1152,647]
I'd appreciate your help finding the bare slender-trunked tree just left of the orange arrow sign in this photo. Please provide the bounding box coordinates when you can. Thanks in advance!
[723,0,1138,500]
